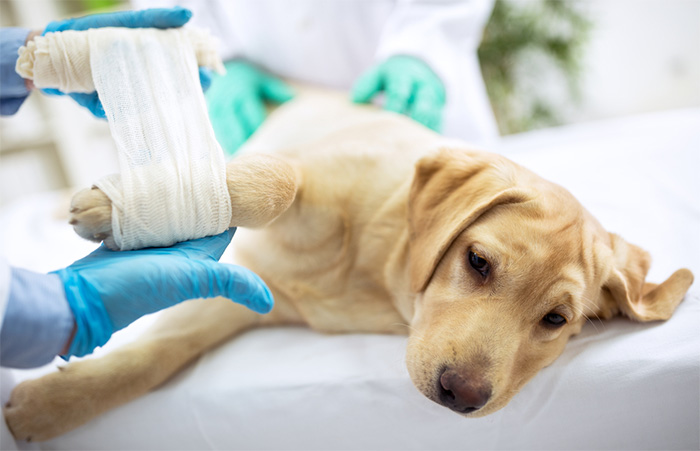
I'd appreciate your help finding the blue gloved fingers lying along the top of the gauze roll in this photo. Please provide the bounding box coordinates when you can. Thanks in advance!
[43,6,192,34]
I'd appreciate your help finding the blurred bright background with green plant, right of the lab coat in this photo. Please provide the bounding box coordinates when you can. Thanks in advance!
[479,0,700,134]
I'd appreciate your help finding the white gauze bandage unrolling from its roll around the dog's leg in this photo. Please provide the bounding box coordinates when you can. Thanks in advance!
[17,28,231,250]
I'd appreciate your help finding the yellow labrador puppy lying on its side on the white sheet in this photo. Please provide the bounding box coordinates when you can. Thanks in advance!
[4,93,693,440]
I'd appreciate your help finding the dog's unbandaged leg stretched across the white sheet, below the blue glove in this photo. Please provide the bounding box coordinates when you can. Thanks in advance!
[3,298,270,441]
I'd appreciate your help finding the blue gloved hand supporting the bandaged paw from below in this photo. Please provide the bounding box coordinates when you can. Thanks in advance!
[55,228,273,356]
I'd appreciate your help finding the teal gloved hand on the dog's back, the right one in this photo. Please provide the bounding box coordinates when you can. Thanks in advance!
[352,56,445,131]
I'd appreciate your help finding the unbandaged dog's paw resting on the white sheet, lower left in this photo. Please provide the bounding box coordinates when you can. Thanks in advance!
[2,371,91,442]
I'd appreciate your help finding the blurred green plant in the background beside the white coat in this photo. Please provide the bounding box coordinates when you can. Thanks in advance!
[478,0,591,134]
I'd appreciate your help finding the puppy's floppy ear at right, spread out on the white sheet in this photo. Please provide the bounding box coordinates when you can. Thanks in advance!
[602,233,693,321]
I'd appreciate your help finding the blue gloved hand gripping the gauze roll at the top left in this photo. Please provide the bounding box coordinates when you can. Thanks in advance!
[42,6,211,119]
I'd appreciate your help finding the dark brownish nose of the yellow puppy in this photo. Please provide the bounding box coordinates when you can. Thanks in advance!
[438,368,491,413]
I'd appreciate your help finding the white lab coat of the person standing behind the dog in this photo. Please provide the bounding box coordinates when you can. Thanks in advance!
[132,0,498,145]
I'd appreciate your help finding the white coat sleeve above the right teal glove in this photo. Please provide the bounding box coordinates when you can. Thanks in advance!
[376,0,498,145]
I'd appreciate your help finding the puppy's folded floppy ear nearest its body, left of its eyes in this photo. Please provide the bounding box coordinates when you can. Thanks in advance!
[408,149,529,292]
